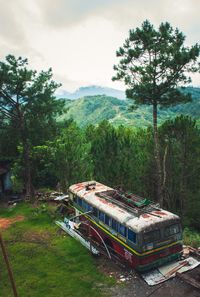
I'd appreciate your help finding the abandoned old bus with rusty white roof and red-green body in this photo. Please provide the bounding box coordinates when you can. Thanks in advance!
[69,182,182,271]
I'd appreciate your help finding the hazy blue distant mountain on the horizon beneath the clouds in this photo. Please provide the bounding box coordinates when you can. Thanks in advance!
[57,86,126,99]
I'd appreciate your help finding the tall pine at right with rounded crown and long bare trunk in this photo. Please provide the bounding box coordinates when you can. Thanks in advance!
[113,21,200,205]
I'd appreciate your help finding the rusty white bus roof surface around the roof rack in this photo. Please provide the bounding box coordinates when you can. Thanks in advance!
[69,181,179,232]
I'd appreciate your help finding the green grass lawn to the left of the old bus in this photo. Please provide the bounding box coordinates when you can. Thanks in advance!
[0,204,114,297]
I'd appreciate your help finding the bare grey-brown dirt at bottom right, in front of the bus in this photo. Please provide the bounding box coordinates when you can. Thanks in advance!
[97,257,200,297]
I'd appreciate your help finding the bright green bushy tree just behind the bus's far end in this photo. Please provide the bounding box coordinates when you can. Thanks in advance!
[51,122,92,191]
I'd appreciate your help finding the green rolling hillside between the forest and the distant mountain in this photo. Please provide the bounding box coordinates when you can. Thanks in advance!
[61,88,200,127]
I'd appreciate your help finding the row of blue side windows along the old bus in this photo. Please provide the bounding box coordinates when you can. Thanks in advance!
[74,196,136,243]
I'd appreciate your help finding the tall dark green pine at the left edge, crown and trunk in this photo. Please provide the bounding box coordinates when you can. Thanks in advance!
[0,55,62,196]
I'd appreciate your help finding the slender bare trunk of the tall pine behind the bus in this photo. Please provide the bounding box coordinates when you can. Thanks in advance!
[153,103,164,207]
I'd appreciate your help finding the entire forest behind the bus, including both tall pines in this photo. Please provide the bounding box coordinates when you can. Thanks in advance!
[0,21,200,231]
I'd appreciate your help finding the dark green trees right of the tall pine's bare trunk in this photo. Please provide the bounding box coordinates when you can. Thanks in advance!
[159,116,200,224]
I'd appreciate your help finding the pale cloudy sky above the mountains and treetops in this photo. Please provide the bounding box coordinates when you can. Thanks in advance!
[0,0,200,91]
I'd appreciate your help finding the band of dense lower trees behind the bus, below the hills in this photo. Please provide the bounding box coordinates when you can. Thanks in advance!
[1,116,200,229]
